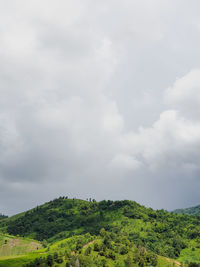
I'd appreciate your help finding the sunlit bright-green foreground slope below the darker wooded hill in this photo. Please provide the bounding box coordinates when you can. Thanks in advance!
[0,234,180,267]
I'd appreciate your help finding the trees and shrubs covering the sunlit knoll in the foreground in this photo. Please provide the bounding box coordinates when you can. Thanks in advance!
[23,233,158,267]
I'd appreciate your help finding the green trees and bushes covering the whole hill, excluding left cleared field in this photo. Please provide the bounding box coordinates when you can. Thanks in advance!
[0,197,200,267]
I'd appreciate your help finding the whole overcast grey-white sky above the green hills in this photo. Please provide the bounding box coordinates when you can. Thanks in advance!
[0,0,200,215]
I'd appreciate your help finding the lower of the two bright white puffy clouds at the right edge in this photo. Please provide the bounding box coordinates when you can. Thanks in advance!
[124,110,200,172]
